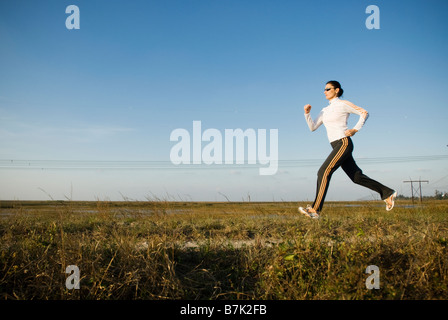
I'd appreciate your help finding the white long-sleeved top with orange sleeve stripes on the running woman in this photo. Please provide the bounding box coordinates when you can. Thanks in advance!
[305,98,369,142]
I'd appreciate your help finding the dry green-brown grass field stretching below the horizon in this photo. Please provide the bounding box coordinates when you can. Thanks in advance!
[0,201,448,300]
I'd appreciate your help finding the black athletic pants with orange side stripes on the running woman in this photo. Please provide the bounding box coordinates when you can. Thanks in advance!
[313,137,394,212]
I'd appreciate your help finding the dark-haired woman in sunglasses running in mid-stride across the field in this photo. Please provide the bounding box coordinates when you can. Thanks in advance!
[299,80,397,219]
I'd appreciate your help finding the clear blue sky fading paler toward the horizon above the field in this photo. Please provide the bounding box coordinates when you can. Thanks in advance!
[0,0,448,201]
